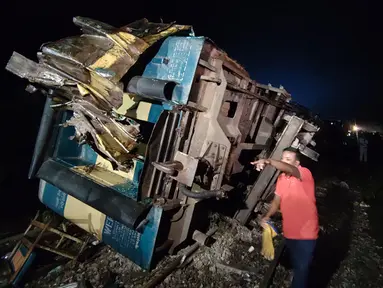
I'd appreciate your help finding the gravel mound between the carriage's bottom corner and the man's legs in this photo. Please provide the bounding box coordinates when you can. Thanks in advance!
[159,218,279,288]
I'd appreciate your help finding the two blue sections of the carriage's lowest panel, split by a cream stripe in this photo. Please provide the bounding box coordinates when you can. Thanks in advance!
[41,183,163,269]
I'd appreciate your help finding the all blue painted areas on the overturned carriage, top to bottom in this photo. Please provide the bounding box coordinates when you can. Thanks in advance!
[35,37,205,269]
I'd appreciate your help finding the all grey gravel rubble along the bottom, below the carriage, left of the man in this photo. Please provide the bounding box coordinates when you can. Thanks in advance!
[27,217,284,288]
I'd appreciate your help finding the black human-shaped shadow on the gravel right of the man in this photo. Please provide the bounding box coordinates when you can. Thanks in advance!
[308,186,354,288]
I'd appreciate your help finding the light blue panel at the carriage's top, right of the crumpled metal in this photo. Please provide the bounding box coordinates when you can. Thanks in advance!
[143,37,205,104]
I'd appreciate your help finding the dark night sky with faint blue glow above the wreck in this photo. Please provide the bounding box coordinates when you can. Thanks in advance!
[1,0,376,121]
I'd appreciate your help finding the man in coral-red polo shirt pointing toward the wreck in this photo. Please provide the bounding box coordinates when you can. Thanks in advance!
[252,148,319,288]
